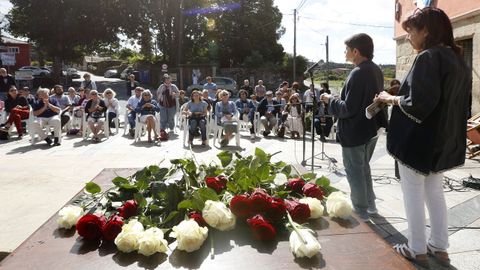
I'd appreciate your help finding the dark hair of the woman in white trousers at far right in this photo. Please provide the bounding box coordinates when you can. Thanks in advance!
[402,7,461,54]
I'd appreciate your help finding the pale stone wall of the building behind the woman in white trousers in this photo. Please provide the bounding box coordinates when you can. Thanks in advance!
[396,15,480,114]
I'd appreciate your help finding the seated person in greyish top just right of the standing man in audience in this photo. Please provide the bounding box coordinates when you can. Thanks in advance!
[184,90,208,146]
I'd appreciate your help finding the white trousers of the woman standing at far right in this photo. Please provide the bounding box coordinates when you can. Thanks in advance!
[398,163,448,254]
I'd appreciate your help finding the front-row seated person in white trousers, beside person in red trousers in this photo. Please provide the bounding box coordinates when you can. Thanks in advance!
[31,88,62,146]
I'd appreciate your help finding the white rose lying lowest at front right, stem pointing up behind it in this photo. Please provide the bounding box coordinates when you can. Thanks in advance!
[289,229,322,258]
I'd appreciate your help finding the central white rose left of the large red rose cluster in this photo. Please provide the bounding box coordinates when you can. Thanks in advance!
[202,200,235,231]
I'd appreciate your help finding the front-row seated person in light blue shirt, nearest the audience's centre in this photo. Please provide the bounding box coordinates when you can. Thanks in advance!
[215,90,238,147]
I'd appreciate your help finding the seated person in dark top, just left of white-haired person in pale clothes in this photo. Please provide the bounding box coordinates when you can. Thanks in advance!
[85,90,107,142]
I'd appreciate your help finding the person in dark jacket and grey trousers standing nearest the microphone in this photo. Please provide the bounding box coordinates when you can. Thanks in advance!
[320,34,383,221]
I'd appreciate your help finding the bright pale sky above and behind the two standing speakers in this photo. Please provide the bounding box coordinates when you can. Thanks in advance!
[0,0,396,64]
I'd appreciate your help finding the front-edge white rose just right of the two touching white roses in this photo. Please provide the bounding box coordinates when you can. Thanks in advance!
[170,219,208,252]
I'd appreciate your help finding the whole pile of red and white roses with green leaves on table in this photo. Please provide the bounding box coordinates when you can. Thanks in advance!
[58,148,352,258]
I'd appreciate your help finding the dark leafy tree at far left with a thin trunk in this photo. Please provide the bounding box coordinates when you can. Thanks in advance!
[7,0,121,81]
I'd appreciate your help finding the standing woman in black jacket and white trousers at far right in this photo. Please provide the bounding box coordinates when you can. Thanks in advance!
[375,7,471,267]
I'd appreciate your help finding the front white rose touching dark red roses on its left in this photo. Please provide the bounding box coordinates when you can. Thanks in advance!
[115,219,143,253]
